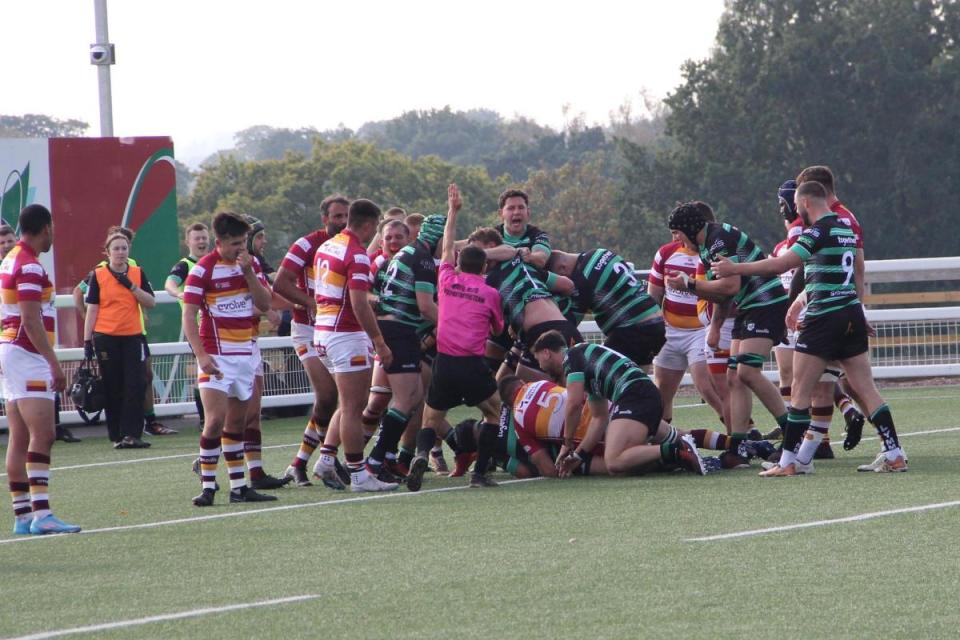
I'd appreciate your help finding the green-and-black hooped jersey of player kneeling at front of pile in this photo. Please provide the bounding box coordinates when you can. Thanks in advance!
[563,342,652,404]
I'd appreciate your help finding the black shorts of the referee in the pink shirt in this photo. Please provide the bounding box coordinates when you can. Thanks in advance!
[427,353,497,411]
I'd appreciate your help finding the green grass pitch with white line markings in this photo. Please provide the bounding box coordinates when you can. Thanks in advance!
[0,385,960,640]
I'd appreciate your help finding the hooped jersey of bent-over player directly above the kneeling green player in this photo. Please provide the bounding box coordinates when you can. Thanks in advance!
[570,249,660,334]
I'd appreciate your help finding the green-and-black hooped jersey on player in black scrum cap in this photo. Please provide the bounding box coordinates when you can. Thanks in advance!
[700,222,787,312]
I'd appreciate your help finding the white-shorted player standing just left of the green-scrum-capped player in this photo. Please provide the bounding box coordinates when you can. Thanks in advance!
[313,199,398,491]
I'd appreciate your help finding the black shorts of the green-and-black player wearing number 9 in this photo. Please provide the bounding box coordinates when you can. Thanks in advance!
[795,304,869,360]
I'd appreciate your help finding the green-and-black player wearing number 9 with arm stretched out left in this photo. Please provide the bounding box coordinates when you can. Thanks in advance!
[713,180,907,477]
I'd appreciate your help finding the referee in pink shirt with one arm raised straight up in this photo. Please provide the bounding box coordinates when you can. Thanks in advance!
[407,184,504,491]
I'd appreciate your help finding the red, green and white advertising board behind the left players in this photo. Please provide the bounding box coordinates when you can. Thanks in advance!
[0,137,180,346]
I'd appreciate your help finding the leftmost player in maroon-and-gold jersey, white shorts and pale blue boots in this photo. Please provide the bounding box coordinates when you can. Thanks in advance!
[0,204,80,535]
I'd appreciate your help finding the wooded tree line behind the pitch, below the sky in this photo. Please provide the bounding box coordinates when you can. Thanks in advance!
[0,0,960,267]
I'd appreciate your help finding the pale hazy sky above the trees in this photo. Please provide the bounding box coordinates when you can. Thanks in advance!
[0,0,723,164]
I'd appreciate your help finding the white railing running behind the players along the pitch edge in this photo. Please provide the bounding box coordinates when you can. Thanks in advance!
[0,257,960,426]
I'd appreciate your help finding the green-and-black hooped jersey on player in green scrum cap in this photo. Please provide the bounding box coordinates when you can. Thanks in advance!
[375,240,437,331]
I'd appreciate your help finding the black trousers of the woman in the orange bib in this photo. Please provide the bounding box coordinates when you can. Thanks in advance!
[93,333,147,442]
